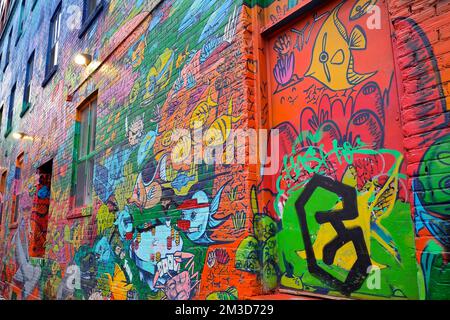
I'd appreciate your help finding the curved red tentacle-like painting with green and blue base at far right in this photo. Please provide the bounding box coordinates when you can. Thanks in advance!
[394,18,450,299]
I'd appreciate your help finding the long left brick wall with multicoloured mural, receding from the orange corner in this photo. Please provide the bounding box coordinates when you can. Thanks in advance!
[0,0,261,299]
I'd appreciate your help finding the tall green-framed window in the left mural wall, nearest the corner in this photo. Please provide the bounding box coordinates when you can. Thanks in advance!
[75,95,97,208]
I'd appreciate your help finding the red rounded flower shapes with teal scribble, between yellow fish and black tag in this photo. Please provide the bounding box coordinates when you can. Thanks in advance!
[278,82,395,196]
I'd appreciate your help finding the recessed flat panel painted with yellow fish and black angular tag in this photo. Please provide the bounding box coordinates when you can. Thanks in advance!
[254,1,430,299]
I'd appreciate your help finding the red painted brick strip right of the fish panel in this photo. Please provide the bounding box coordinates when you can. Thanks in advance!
[389,1,450,299]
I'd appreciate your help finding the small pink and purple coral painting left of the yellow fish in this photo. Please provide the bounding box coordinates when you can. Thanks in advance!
[273,34,302,93]
